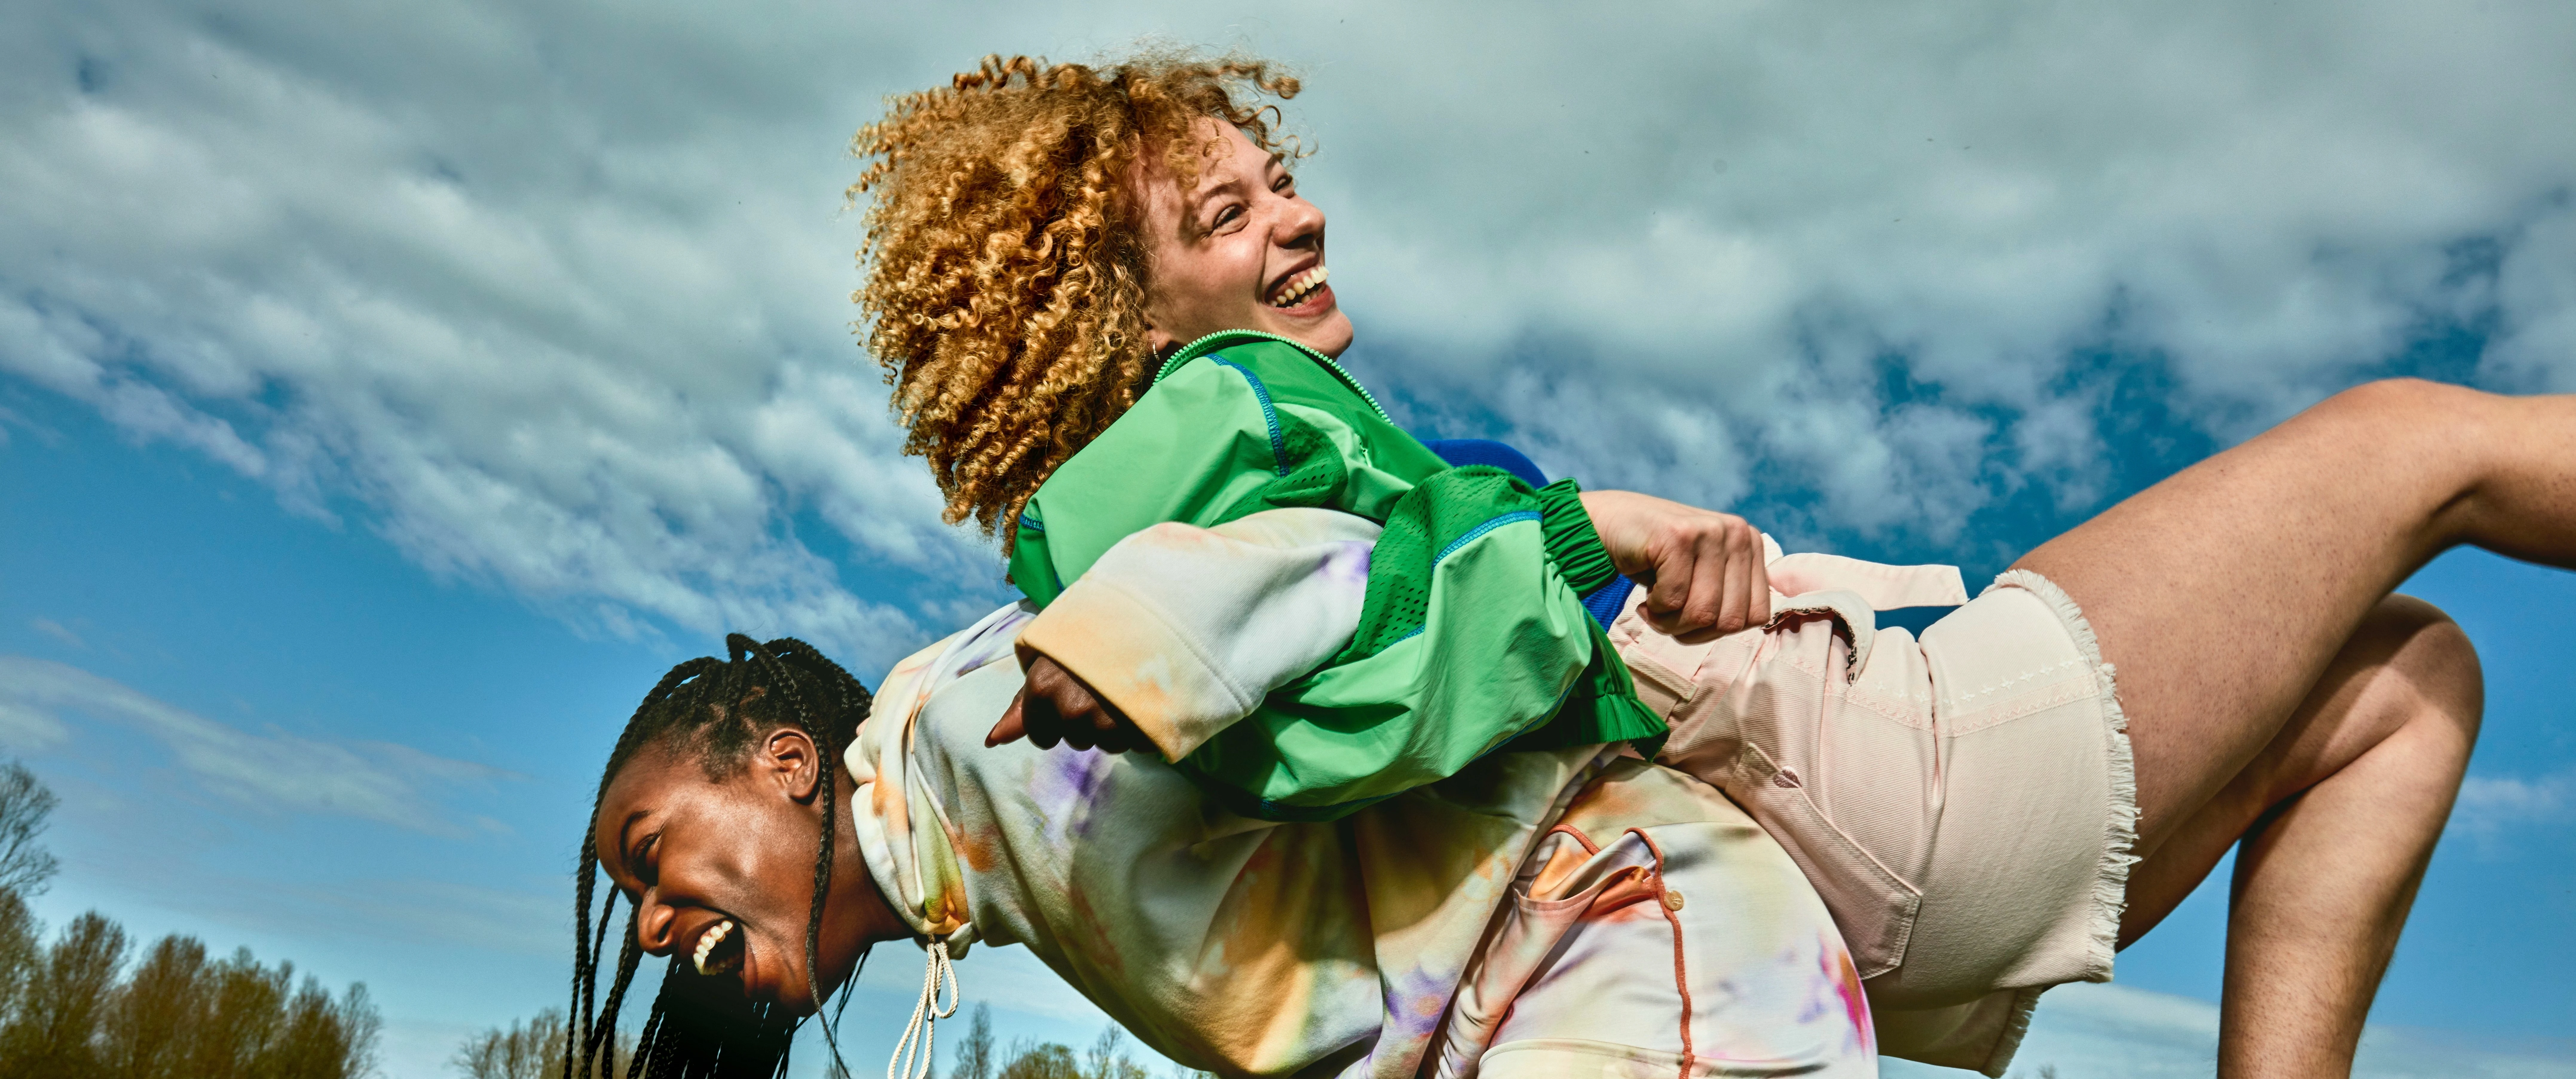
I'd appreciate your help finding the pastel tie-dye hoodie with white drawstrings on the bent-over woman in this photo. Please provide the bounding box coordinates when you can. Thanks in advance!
[845,608,1868,1079]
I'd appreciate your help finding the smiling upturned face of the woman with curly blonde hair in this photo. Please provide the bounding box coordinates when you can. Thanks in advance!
[1139,118,1350,355]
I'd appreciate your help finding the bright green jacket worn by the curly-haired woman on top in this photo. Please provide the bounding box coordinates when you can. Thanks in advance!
[1010,330,1664,822]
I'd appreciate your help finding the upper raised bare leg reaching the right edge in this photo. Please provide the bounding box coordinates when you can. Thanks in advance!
[2020,381,2576,1074]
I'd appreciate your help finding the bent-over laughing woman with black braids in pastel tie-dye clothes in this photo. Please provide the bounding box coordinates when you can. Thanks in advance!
[579,620,1875,1079]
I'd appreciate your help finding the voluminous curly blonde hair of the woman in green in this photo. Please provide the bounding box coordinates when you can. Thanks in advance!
[848,51,1298,549]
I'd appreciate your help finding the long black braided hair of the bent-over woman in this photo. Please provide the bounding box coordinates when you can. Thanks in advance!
[564,634,871,1079]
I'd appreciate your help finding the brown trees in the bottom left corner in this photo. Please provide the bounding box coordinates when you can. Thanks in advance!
[0,762,384,1079]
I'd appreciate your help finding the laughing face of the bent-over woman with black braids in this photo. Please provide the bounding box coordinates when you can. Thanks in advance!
[590,729,909,1015]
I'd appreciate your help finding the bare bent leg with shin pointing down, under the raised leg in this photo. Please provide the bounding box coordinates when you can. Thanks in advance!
[2120,595,2483,1076]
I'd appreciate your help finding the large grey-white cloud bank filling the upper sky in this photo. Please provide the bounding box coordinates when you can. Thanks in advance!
[0,0,2576,651]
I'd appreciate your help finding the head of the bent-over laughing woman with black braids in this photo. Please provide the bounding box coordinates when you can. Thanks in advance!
[564,634,899,1076]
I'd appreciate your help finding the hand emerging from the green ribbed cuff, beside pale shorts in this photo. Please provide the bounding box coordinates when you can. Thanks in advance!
[1584,492,1770,639]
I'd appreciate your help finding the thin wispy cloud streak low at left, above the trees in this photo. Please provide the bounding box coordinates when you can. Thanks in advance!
[0,657,515,834]
